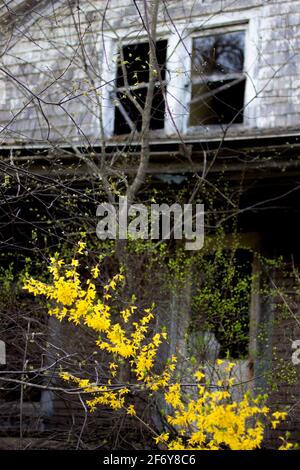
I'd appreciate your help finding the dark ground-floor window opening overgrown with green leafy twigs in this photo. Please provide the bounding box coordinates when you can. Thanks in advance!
[190,249,253,360]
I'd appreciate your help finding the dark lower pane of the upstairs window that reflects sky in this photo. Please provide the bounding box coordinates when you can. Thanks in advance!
[189,79,246,126]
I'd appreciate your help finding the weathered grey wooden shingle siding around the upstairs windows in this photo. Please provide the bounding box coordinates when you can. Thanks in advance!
[0,0,300,144]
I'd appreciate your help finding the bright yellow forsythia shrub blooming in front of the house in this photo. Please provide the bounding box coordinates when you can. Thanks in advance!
[24,242,292,450]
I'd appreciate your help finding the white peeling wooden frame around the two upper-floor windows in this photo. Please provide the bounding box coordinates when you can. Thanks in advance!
[99,18,259,142]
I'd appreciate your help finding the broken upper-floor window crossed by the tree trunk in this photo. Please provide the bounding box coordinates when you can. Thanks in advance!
[114,40,167,135]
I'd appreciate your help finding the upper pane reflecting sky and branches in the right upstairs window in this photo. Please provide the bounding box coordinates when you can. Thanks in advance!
[192,31,245,77]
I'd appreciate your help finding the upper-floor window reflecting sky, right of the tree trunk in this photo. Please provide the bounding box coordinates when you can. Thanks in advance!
[189,31,246,126]
